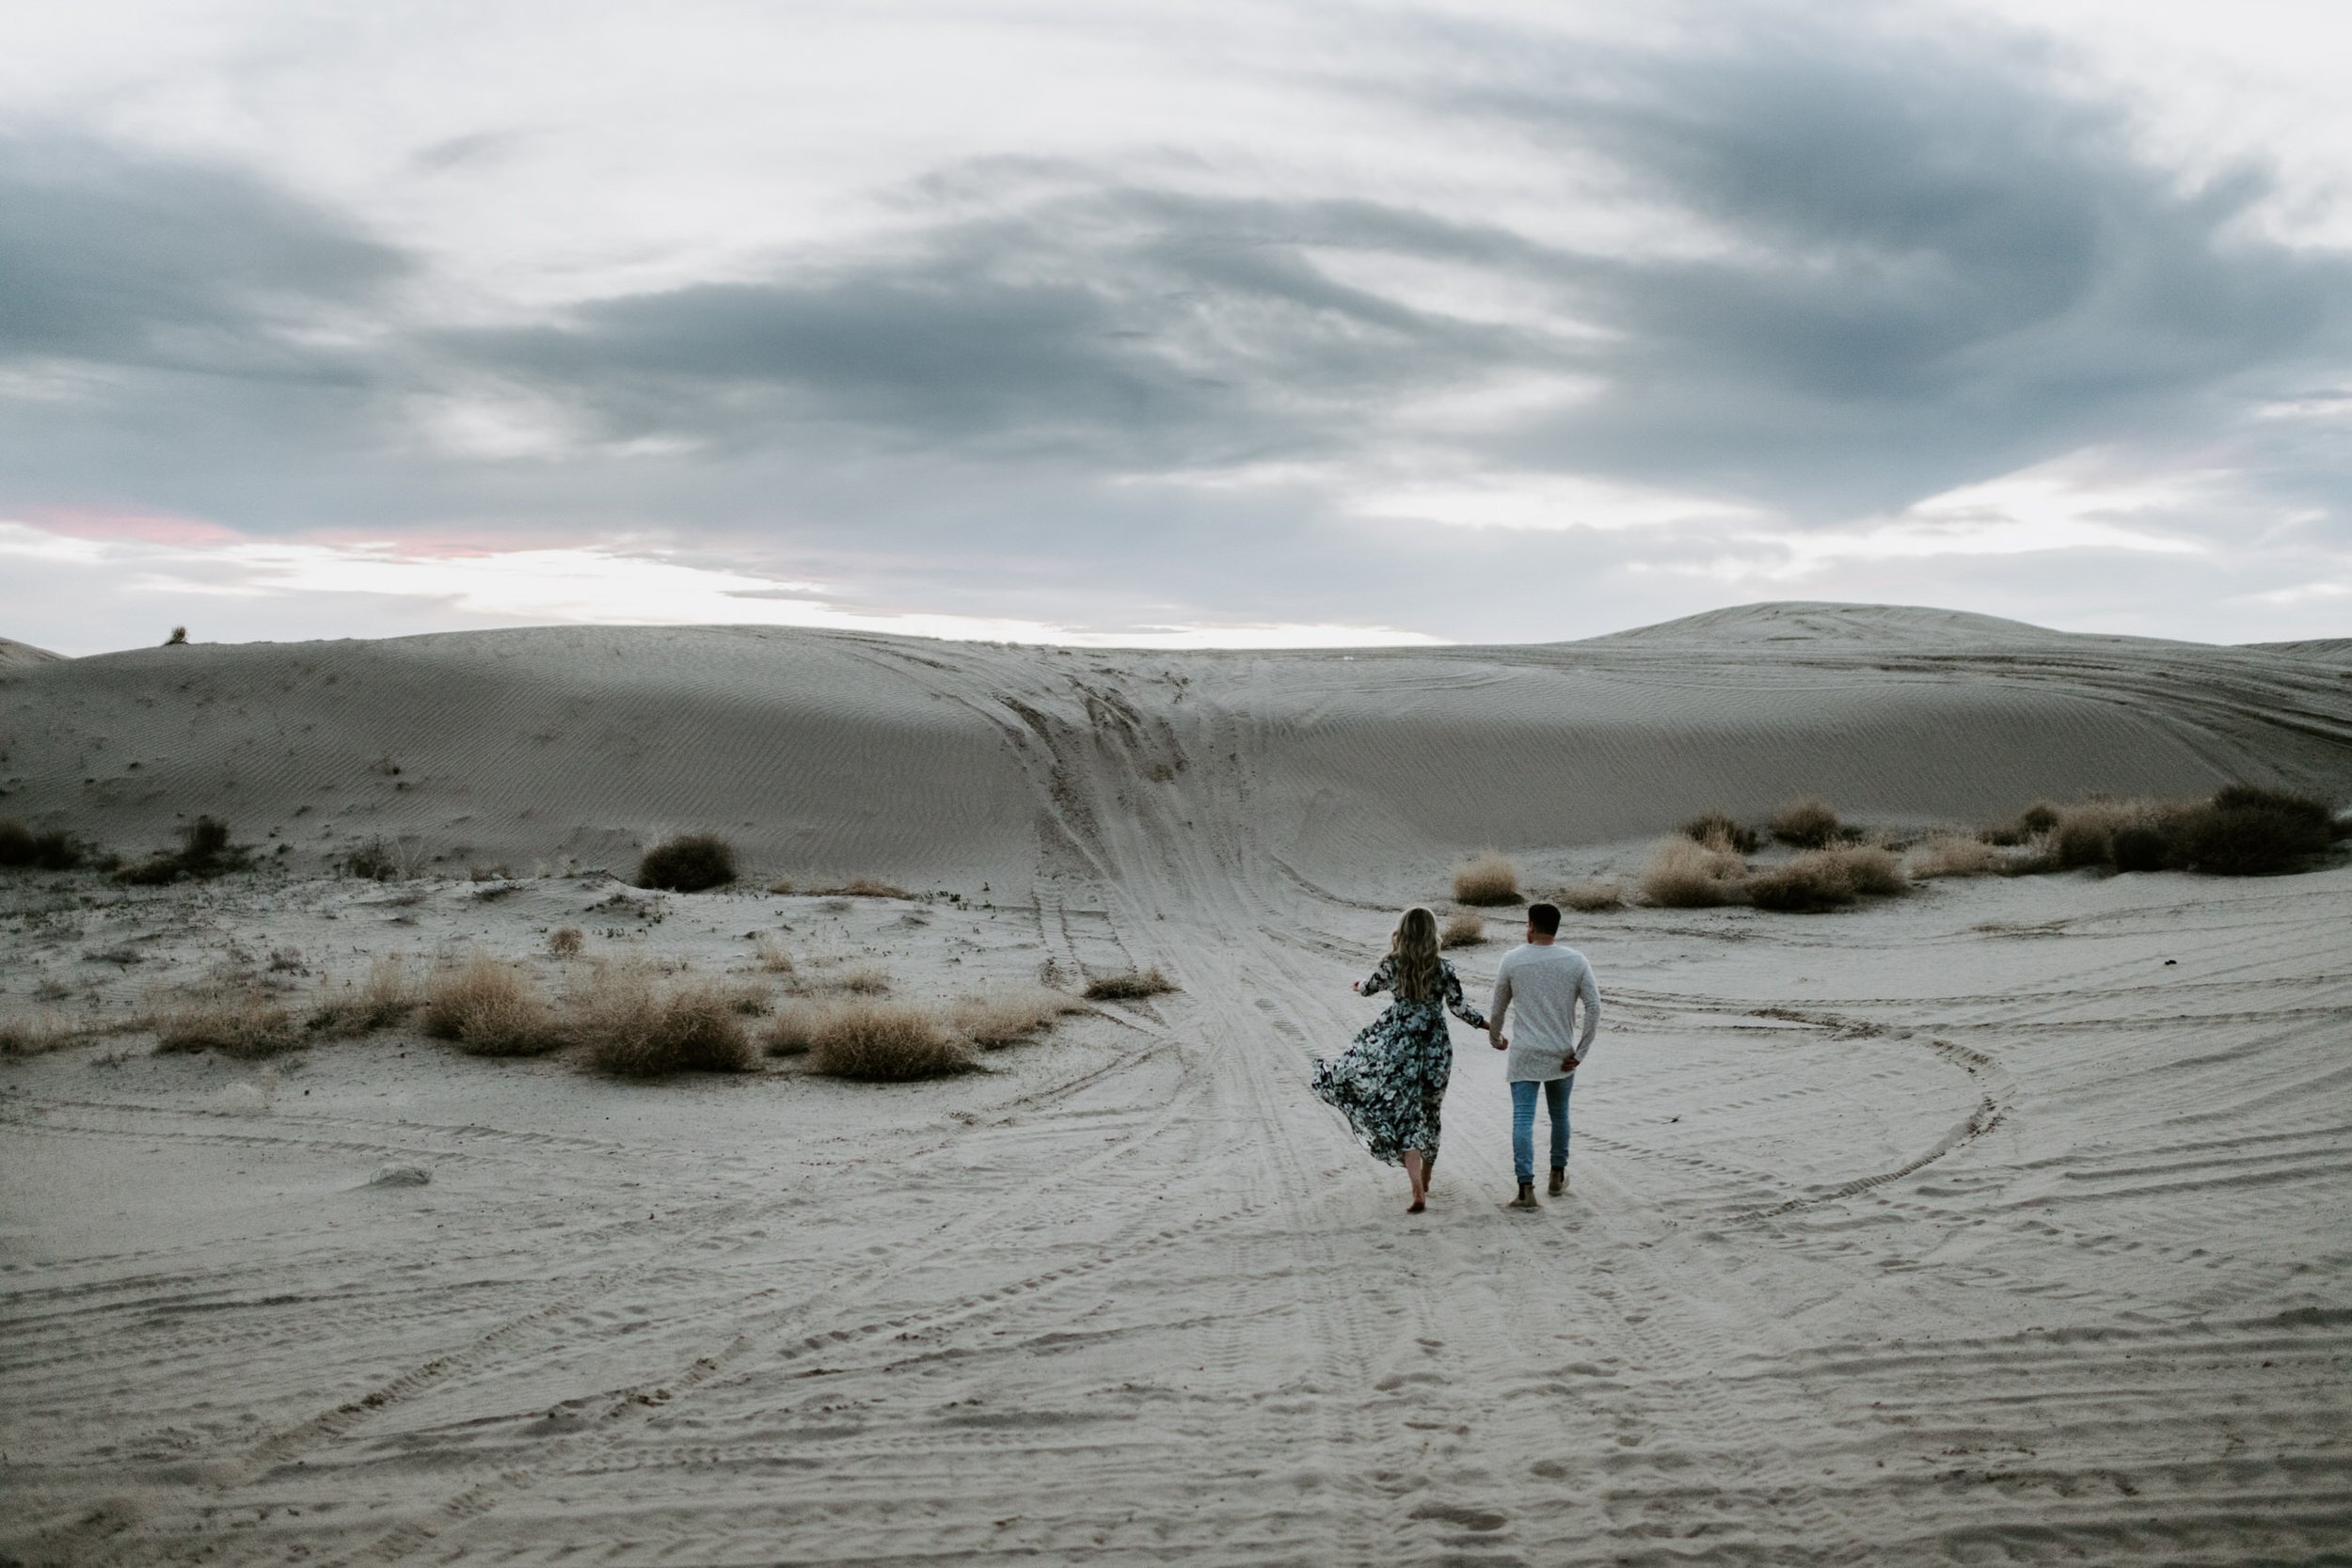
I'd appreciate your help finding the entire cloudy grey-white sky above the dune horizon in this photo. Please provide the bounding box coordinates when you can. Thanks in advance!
[0,0,2352,654]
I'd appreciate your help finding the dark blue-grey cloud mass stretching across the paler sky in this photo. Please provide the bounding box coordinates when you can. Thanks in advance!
[0,3,2352,635]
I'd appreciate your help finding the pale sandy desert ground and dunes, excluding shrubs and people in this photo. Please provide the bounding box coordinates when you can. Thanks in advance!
[0,604,2352,1566]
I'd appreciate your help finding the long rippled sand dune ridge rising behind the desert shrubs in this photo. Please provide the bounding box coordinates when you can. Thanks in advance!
[0,607,2352,886]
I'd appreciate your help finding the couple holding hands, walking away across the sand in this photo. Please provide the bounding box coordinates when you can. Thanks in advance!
[1312,903,1602,1213]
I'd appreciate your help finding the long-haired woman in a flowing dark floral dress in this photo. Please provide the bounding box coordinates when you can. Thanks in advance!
[1315,910,1486,1213]
